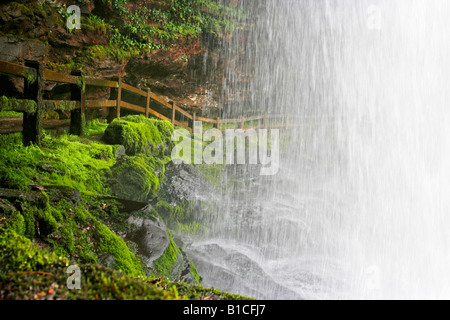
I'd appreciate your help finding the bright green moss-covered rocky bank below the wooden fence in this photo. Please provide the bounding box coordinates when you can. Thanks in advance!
[0,117,246,299]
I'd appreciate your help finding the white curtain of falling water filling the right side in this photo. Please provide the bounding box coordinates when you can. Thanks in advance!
[190,0,450,299]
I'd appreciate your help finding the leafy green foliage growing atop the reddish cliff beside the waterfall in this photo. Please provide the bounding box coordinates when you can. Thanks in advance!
[102,0,242,50]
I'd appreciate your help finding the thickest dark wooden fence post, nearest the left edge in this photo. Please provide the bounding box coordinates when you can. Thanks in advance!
[23,61,44,146]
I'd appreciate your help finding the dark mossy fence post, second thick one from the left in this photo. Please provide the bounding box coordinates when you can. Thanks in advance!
[69,70,85,136]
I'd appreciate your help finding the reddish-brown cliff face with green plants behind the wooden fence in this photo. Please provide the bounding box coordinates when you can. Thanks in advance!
[0,0,232,111]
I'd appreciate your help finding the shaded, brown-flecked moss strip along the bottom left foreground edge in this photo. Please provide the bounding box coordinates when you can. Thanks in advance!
[0,264,186,300]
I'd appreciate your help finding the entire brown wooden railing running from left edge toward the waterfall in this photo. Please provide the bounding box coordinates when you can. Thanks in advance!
[0,60,300,145]
